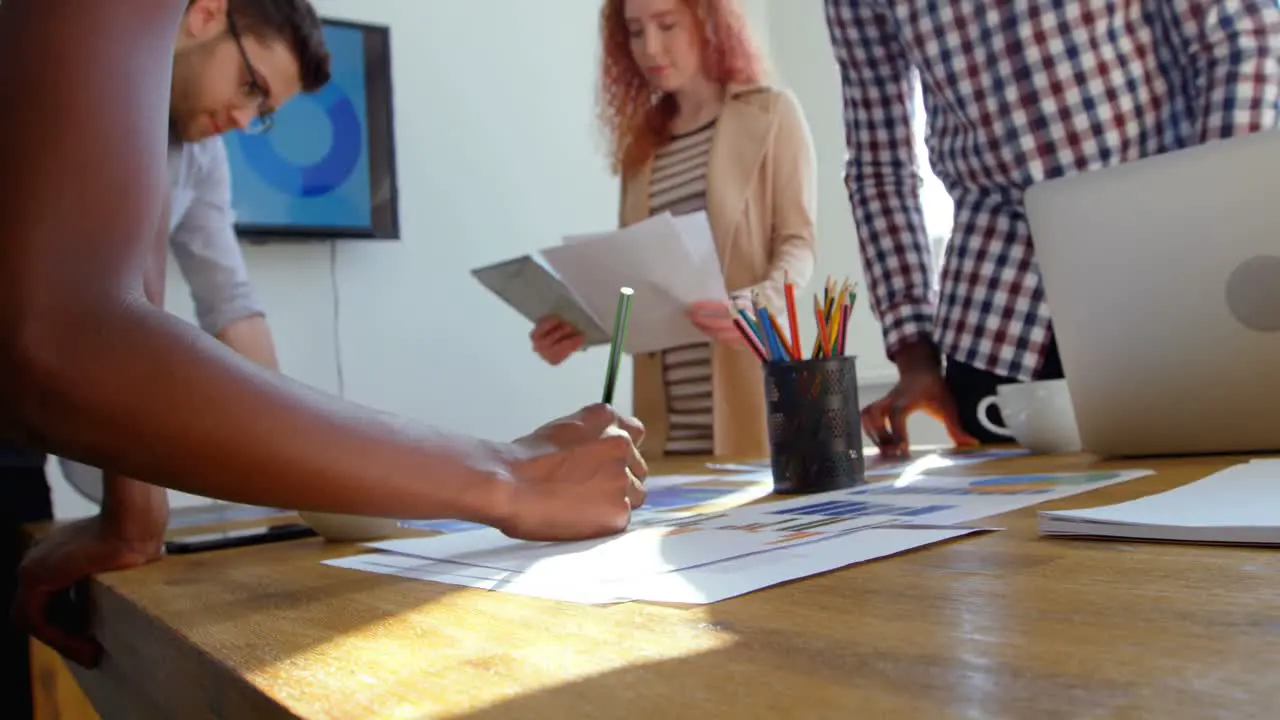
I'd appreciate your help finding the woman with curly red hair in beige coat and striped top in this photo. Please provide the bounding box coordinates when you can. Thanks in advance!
[531,0,817,457]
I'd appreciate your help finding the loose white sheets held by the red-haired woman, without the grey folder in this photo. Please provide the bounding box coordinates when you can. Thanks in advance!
[543,213,728,355]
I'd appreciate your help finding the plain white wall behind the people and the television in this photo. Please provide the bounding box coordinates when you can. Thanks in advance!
[51,0,952,516]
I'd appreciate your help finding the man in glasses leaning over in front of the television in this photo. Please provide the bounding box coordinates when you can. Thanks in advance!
[169,0,329,369]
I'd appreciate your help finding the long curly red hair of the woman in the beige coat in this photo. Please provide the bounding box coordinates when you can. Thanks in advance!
[596,0,764,174]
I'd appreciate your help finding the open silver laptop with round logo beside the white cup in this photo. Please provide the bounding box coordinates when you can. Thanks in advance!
[1025,131,1280,456]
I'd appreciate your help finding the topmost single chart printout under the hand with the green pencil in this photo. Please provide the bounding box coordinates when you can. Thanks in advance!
[367,470,1149,591]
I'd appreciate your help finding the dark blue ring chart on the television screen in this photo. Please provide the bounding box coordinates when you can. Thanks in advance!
[241,82,364,197]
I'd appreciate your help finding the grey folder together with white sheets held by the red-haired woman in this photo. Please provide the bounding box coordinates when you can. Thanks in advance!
[472,213,728,355]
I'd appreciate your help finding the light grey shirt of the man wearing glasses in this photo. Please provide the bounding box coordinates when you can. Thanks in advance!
[169,136,265,334]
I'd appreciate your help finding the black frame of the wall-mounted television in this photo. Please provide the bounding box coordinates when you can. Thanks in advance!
[233,17,401,245]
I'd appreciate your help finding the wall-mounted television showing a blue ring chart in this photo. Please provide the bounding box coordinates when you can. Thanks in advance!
[225,19,399,242]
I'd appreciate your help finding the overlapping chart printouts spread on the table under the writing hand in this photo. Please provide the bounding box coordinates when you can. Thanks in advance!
[326,470,1151,603]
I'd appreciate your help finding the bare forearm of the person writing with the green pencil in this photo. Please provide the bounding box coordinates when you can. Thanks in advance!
[19,297,506,521]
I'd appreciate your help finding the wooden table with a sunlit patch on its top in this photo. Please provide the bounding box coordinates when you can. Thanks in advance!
[24,457,1280,720]
